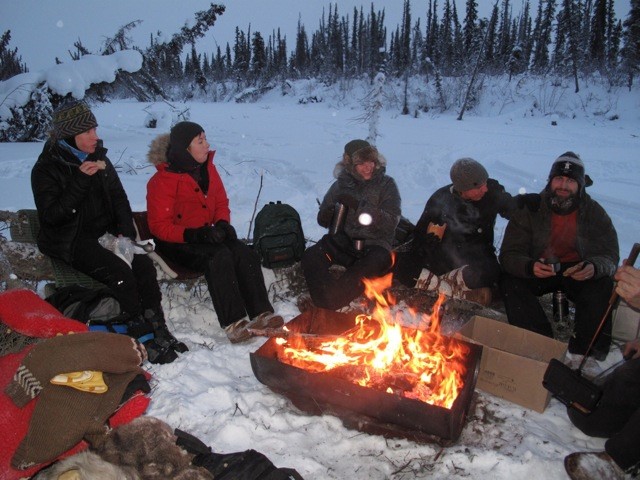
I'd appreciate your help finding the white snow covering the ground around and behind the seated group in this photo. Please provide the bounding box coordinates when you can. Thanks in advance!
[0,59,640,480]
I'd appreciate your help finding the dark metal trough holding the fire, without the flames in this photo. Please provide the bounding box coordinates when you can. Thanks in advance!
[250,308,482,443]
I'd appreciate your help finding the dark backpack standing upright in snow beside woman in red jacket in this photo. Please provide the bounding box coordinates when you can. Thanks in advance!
[253,201,306,268]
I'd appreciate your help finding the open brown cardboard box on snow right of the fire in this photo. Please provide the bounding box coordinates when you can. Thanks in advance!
[456,315,567,412]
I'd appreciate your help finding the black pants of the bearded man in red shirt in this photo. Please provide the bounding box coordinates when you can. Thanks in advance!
[500,274,613,354]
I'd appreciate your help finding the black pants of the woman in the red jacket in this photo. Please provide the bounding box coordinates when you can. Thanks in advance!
[156,240,273,328]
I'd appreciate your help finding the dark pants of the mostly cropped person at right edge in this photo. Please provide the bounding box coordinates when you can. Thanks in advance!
[567,359,640,470]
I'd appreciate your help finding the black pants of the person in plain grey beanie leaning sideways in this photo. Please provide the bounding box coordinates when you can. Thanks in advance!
[393,251,500,288]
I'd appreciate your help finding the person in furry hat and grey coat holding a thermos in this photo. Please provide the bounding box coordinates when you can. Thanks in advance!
[302,140,401,310]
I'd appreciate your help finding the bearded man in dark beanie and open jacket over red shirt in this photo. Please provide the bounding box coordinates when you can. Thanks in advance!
[499,152,619,360]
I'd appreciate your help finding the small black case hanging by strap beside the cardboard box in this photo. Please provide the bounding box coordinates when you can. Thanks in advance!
[542,358,602,415]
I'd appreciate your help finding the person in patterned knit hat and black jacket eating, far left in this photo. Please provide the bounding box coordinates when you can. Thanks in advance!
[31,100,188,363]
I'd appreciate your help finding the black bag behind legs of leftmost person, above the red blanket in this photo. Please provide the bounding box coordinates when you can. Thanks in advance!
[45,285,126,333]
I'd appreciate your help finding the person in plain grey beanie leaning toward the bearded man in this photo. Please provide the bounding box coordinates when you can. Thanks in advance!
[394,158,540,306]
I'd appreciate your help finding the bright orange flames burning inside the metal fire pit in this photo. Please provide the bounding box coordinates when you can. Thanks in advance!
[278,274,469,408]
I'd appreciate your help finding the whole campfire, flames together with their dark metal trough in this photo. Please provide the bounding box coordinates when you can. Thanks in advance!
[251,275,482,441]
